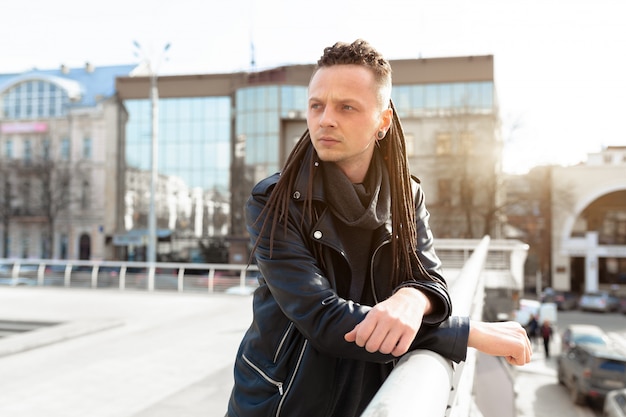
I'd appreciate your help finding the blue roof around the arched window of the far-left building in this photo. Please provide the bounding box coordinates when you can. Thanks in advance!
[0,65,136,107]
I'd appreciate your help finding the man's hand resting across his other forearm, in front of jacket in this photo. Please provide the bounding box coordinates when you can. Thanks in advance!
[344,287,432,356]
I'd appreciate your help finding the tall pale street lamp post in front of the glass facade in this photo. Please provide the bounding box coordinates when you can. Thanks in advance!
[133,41,170,263]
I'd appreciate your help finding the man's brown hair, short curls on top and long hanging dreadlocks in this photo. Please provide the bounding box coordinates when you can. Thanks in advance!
[252,39,433,286]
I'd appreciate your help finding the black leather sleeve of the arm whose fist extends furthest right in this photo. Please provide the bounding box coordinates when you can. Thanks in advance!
[246,179,467,363]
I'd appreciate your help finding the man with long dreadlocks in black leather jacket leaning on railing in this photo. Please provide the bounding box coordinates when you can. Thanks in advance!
[227,40,532,417]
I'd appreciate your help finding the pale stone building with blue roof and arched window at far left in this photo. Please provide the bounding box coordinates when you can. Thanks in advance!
[0,64,134,259]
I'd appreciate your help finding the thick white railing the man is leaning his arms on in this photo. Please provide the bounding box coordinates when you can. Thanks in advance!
[361,236,490,417]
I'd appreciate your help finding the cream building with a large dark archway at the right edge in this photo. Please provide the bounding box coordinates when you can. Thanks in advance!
[552,146,626,293]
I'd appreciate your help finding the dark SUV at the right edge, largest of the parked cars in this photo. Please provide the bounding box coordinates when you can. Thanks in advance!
[557,343,626,405]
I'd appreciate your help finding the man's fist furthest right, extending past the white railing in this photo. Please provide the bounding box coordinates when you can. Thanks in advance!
[467,321,533,365]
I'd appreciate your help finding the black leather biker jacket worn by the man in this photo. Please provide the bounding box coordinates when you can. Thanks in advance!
[228,150,469,417]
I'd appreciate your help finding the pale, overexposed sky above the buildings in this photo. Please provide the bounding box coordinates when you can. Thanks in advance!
[0,0,626,174]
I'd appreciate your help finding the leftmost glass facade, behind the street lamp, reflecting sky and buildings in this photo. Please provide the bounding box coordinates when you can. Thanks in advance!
[124,97,232,260]
